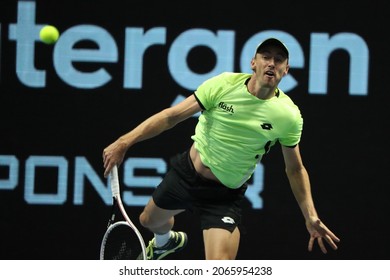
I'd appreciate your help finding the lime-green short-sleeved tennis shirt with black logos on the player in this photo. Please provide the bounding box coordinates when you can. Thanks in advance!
[191,72,303,188]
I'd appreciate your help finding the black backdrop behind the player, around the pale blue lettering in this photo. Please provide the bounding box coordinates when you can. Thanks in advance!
[0,0,390,260]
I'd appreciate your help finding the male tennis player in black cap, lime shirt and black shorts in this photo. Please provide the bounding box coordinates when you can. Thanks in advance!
[103,38,340,260]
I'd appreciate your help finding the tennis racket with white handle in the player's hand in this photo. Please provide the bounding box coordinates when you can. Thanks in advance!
[100,166,146,260]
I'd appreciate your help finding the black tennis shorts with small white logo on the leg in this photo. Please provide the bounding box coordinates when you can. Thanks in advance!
[152,150,247,232]
